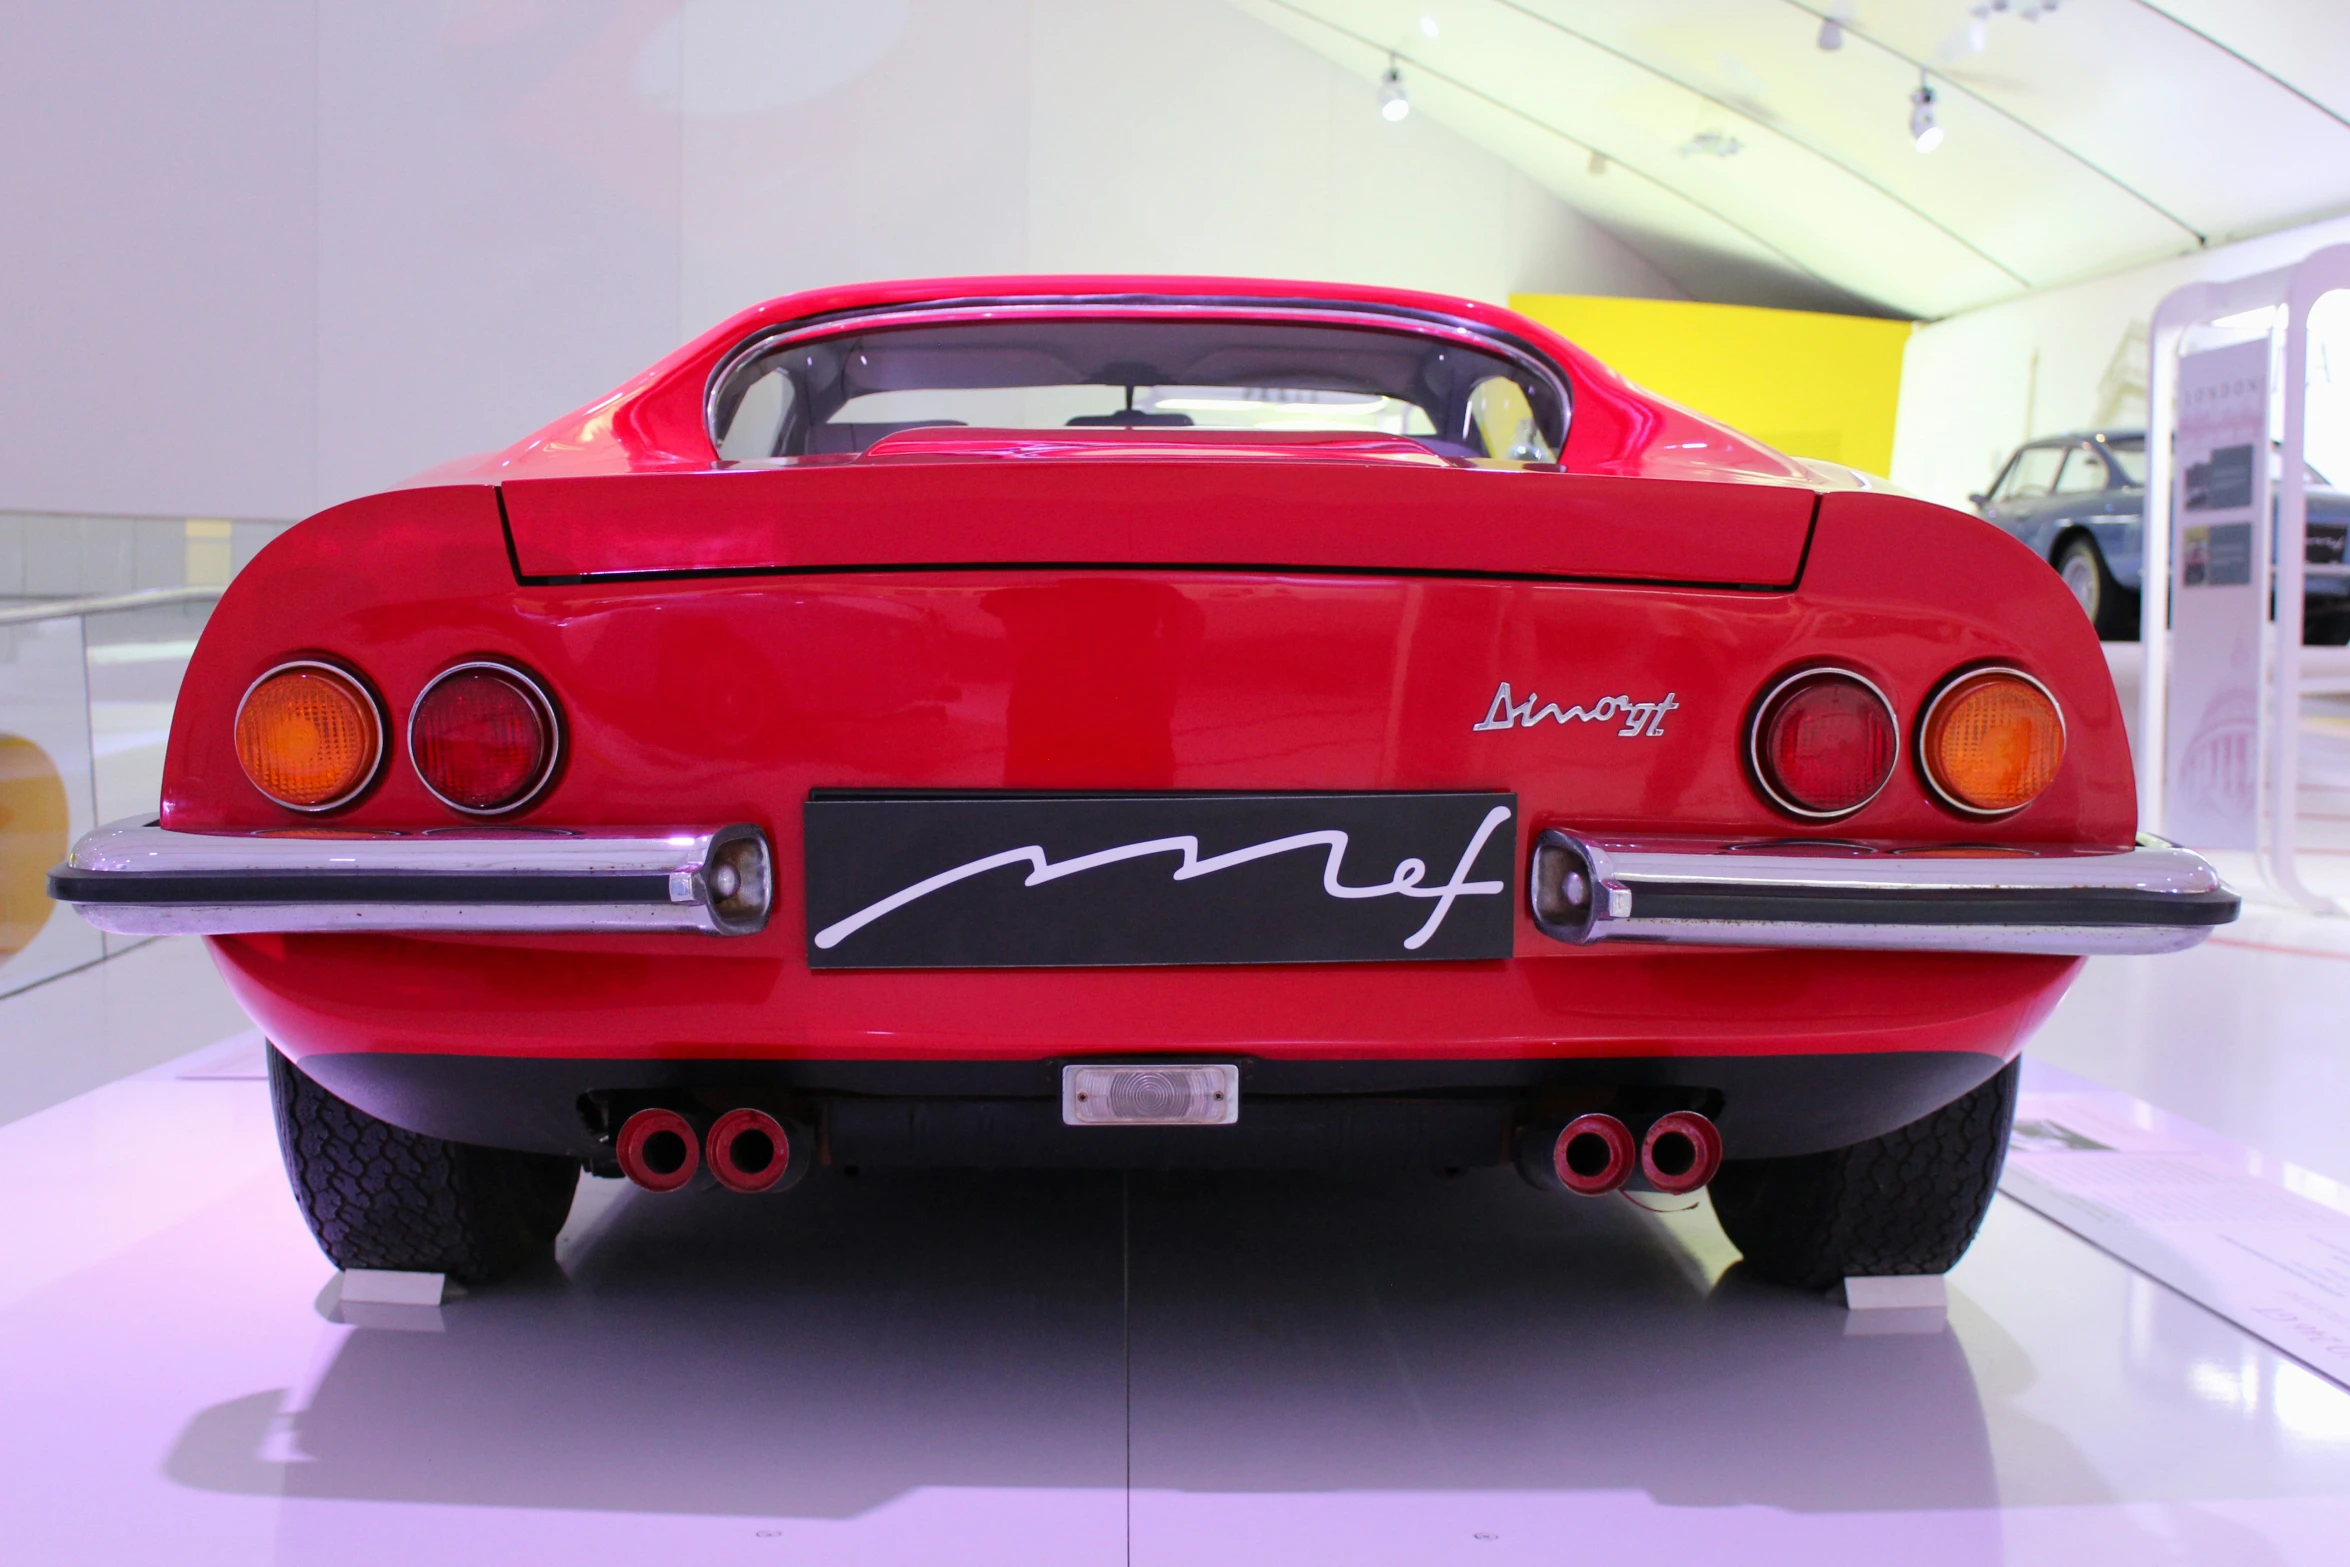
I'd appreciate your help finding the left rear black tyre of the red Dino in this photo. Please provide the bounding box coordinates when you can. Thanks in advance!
[270,1045,580,1283]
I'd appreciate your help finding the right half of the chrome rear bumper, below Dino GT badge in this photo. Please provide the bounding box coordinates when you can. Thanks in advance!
[1528,827,2237,956]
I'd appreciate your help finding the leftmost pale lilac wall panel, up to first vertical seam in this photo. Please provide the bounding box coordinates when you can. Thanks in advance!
[0,0,317,517]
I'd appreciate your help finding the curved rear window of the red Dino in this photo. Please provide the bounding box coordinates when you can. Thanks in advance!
[710,317,1567,463]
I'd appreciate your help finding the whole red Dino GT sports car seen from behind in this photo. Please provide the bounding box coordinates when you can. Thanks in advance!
[52,277,2237,1285]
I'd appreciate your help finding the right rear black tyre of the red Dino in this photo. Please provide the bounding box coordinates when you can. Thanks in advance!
[1711,1062,2021,1290]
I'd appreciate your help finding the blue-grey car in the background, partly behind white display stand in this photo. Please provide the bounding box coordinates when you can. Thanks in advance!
[1972,430,2350,644]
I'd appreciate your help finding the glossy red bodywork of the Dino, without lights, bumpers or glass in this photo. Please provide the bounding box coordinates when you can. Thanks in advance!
[162,277,2136,1165]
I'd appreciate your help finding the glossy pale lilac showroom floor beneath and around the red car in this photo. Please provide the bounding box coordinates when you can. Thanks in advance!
[0,944,2350,1567]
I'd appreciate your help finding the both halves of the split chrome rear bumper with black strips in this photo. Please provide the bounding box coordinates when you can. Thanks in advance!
[49,822,2237,954]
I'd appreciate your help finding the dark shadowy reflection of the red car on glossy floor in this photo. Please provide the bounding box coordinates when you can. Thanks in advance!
[167,1172,1998,1518]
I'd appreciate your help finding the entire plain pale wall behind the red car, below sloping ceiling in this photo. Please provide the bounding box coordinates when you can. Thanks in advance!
[0,0,1680,517]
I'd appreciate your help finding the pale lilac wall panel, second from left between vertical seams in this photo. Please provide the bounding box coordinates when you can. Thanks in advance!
[312,0,682,523]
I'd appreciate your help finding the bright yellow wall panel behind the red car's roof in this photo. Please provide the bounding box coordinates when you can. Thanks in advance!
[1509,294,1911,475]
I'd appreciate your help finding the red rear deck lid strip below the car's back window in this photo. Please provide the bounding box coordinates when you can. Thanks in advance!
[501,451,1814,587]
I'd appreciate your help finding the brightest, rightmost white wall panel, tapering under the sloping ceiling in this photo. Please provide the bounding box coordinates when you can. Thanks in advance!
[1027,0,1654,303]
